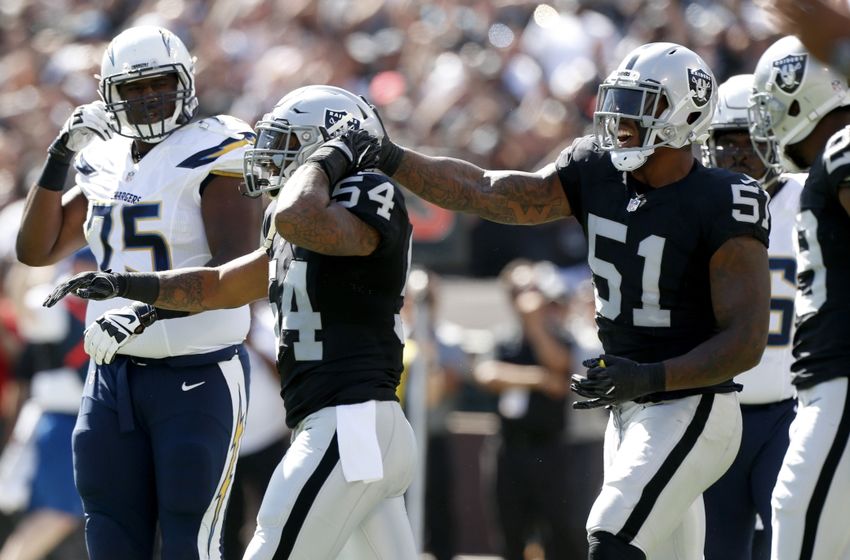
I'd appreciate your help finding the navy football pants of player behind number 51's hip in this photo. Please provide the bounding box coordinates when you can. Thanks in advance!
[703,399,796,560]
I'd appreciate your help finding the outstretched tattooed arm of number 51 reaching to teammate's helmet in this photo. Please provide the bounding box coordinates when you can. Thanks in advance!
[393,152,572,224]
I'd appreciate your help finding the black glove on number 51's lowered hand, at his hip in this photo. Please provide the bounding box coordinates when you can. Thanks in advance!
[570,354,666,410]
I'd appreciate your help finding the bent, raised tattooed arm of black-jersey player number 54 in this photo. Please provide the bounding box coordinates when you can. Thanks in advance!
[274,165,381,256]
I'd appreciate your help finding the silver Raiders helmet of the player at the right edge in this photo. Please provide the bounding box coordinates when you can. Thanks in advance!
[749,36,850,172]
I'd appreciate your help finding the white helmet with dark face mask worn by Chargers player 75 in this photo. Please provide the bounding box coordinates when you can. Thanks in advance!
[99,25,198,143]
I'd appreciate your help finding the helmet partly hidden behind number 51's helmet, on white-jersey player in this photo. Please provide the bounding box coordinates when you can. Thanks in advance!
[701,74,781,188]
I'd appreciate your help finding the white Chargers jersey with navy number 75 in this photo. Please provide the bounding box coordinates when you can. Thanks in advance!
[75,115,253,358]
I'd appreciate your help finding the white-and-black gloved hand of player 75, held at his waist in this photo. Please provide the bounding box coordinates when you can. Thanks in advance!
[84,303,153,365]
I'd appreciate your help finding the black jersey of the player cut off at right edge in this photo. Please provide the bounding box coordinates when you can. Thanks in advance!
[791,127,850,387]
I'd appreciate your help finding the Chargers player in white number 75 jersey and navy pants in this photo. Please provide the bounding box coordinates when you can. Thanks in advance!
[17,26,261,560]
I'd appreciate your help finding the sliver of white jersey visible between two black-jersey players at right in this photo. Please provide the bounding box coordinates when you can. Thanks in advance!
[735,173,806,404]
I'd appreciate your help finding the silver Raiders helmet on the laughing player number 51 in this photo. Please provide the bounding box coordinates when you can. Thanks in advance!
[593,43,717,171]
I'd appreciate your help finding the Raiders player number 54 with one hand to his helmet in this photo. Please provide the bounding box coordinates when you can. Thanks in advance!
[43,86,417,560]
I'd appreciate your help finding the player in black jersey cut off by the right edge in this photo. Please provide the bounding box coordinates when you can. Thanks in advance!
[750,36,850,560]
